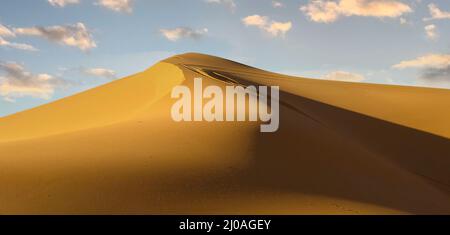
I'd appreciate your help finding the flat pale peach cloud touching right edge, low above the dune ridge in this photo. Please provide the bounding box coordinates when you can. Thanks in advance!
[392,54,450,69]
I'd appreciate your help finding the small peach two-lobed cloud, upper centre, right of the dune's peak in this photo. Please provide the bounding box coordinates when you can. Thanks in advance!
[242,15,292,37]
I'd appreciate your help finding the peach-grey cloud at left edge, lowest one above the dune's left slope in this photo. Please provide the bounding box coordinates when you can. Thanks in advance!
[0,62,64,102]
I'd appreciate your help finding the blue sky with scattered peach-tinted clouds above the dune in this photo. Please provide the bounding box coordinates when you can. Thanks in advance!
[0,0,450,117]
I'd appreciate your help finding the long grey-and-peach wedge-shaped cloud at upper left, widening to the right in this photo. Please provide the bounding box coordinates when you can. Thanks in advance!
[14,23,97,51]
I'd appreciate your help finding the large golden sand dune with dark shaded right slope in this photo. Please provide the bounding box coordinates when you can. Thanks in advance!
[0,53,450,214]
